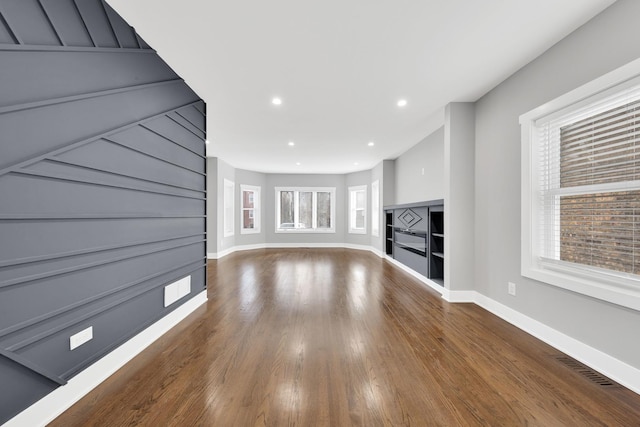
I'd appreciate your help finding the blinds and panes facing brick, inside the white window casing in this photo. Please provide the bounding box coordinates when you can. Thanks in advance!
[536,81,640,275]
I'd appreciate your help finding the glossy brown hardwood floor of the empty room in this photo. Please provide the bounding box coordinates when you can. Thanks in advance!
[51,249,640,427]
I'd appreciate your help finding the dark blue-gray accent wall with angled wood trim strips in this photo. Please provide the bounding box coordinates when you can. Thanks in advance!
[0,0,206,424]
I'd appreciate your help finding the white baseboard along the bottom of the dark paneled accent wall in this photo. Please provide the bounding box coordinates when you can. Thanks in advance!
[3,290,207,427]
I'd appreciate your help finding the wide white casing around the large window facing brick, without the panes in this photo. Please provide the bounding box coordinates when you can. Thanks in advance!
[519,59,640,310]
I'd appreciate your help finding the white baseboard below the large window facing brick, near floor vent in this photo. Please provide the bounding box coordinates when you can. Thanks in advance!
[470,291,640,394]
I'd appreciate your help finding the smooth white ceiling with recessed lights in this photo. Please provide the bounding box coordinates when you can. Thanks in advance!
[108,0,614,173]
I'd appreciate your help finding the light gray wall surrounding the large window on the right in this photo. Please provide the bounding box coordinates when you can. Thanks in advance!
[475,0,640,368]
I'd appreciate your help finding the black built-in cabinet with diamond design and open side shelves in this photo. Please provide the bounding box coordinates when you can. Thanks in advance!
[384,200,444,286]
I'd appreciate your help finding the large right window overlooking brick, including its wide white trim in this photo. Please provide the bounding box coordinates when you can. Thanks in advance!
[519,59,640,311]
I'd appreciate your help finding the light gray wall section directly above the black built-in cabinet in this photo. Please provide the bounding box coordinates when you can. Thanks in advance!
[394,127,445,204]
